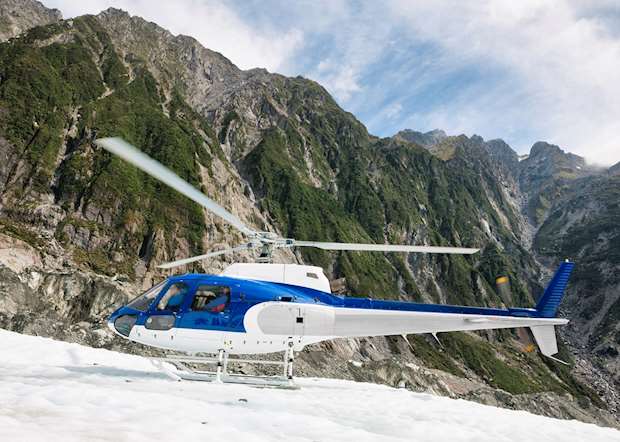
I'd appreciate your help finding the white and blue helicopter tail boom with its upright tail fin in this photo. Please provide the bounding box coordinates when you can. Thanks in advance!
[244,262,574,358]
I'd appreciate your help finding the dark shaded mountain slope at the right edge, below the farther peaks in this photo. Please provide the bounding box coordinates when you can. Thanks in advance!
[534,171,620,384]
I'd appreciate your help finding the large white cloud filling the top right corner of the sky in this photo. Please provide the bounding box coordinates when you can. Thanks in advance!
[382,1,620,164]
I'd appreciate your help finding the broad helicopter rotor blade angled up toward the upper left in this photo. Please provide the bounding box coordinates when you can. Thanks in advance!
[95,138,256,236]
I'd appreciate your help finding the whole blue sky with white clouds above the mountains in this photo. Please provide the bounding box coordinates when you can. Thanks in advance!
[43,0,620,165]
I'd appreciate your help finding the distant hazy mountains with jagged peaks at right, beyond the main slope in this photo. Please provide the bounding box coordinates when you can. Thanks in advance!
[400,130,620,410]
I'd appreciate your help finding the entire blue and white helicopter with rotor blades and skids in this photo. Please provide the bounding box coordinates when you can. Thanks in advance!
[95,138,574,385]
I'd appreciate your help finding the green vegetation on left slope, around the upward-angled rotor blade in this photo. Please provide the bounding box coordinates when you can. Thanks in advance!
[0,16,221,273]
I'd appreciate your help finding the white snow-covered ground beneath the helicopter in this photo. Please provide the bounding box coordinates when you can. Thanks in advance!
[0,330,620,442]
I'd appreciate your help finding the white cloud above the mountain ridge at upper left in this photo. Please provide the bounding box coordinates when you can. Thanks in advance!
[43,0,303,71]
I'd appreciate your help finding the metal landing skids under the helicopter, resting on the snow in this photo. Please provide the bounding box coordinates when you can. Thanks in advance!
[152,348,299,390]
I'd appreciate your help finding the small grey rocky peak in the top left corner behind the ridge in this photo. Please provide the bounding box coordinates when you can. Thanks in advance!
[0,0,62,42]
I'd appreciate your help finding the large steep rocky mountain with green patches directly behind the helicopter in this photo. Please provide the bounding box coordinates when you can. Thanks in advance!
[0,2,617,425]
